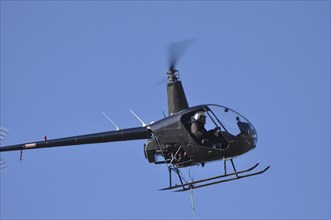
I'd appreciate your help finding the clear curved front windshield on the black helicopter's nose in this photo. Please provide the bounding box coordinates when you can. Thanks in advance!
[204,105,257,146]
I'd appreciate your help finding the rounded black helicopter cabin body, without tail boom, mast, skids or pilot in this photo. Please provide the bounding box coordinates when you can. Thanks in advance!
[145,105,257,166]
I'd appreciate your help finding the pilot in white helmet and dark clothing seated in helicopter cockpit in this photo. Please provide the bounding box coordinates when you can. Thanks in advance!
[191,111,219,145]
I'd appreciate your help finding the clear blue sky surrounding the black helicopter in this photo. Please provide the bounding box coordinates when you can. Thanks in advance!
[0,1,330,219]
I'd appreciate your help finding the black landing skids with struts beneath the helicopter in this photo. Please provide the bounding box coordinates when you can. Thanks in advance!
[160,159,270,192]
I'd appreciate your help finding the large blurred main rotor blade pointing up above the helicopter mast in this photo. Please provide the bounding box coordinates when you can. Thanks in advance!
[168,39,194,70]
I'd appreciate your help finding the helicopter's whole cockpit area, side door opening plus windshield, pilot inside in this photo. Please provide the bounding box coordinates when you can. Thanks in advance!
[181,105,257,149]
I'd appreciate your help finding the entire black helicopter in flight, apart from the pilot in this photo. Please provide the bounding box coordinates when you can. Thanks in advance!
[0,43,270,192]
